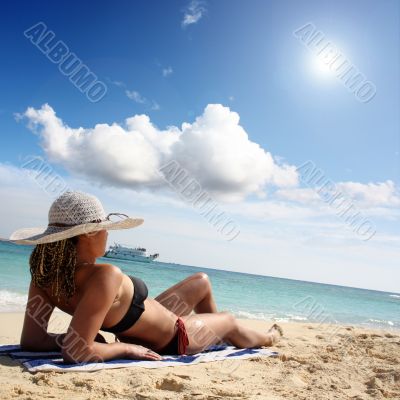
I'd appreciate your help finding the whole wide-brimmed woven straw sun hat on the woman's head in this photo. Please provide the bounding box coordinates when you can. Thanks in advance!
[9,191,143,244]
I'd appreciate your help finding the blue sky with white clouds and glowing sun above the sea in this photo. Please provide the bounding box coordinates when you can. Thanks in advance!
[0,0,400,291]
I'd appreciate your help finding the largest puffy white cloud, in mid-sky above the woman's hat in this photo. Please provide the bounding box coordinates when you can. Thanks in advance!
[20,104,298,201]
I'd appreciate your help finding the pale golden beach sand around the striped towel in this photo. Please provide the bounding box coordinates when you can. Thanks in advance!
[0,313,400,400]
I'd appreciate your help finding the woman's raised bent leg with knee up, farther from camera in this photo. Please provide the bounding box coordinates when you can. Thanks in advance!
[155,272,217,316]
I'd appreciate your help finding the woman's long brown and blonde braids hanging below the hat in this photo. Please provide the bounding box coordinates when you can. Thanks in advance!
[29,236,78,303]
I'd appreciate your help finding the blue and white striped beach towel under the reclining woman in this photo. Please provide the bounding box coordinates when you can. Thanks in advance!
[0,345,278,372]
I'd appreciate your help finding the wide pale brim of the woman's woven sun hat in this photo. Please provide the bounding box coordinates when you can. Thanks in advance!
[8,217,144,245]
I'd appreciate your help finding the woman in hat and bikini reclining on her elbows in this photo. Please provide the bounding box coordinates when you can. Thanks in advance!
[10,192,282,363]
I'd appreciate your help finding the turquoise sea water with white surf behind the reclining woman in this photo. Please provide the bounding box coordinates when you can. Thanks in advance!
[0,242,400,330]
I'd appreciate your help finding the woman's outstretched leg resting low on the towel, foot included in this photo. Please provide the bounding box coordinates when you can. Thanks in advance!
[182,312,282,354]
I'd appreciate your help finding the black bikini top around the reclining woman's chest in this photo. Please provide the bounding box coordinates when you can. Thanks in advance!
[101,275,149,333]
